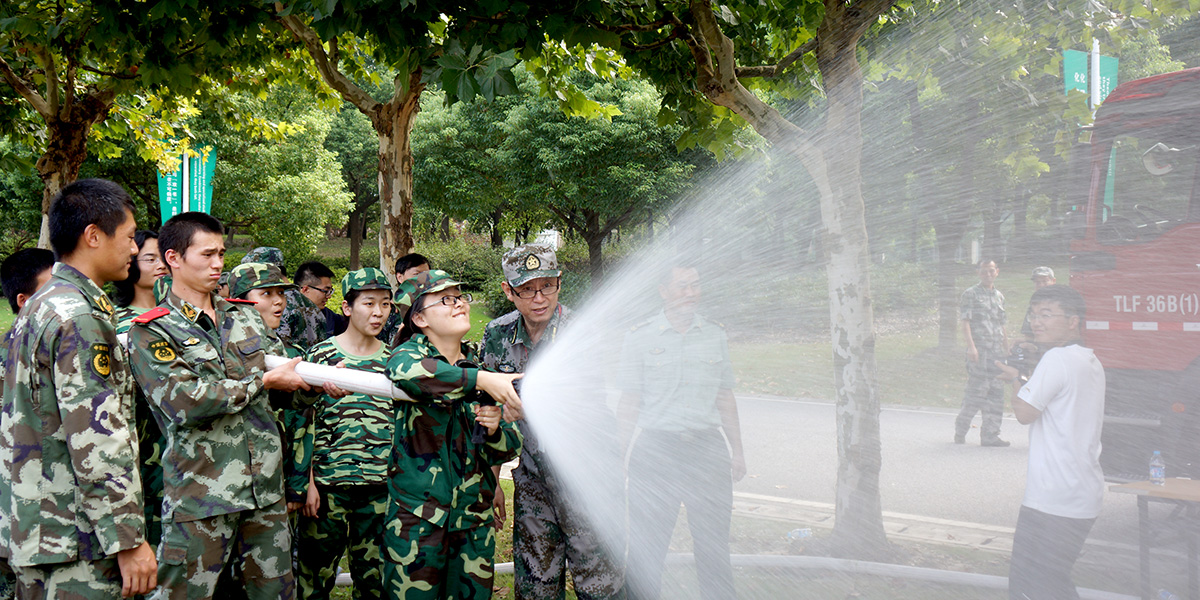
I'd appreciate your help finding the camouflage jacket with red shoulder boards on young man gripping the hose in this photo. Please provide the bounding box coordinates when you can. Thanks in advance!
[130,292,290,522]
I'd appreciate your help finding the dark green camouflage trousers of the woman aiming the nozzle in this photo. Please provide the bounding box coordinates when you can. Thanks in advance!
[383,504,496,600]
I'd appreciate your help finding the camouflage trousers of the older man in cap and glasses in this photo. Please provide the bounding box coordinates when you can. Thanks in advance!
[512,467,625,600]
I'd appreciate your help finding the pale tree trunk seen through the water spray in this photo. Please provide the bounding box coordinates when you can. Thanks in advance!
[817,14,887,556]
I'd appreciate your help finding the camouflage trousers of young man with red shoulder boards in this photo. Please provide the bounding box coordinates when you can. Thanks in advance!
[150,500,295,600]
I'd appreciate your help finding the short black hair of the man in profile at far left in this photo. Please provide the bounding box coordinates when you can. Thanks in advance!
[49,179,134,258]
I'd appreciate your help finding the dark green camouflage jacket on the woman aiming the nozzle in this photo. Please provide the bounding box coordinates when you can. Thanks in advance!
[388,334,521,530]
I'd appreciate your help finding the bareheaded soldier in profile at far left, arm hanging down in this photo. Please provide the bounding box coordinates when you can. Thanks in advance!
[0,179,156,599]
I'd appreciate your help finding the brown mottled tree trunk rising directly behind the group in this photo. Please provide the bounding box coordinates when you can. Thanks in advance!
[367,68,425,272]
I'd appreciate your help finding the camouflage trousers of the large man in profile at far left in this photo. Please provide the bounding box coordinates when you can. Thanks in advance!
[13,557,121,600]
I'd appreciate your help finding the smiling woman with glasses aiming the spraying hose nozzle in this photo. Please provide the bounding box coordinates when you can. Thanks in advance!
[383,270,521,600]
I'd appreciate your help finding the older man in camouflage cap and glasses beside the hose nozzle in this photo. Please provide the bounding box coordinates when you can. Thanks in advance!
[480,244,624,599]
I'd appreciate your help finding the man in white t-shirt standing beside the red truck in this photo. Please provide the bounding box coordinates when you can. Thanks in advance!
[997,286,1104,600]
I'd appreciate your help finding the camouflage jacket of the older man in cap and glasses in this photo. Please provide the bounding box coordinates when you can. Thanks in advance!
[479,305,571,474]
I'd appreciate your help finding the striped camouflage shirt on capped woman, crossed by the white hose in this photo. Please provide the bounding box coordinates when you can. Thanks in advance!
[307,338,392,486]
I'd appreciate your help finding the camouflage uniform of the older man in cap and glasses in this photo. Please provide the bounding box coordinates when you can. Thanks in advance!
[480,305,624,599]
